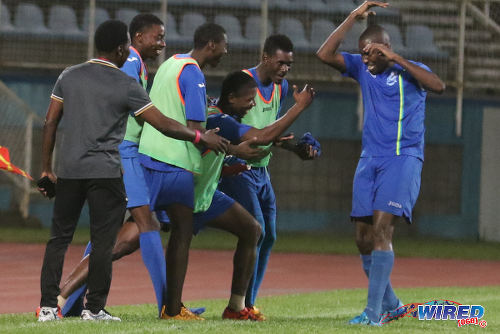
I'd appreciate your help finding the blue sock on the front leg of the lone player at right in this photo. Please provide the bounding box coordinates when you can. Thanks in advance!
[365,251,394,322]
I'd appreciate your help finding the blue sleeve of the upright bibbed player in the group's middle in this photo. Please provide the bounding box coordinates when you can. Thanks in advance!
[179,65,207,122]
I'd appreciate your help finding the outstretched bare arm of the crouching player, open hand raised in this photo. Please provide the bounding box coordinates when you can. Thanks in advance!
[241,85,315,145]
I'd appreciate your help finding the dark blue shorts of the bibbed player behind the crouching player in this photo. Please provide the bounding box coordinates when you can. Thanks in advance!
[219,167,276,230]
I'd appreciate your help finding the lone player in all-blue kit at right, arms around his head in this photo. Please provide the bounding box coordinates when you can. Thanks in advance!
[316,1,445,326]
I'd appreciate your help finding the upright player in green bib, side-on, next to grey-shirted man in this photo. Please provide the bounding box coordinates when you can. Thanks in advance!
[139,23,227,320]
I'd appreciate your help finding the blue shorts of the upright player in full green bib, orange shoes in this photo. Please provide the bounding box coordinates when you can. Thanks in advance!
[143,166,194,210]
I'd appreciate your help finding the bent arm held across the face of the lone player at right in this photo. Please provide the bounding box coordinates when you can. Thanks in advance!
[363,43,446,94]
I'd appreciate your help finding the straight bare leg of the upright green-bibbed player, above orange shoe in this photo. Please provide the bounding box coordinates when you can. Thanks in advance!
[164,203,193,317]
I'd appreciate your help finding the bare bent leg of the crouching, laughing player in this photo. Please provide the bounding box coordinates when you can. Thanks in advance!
[207,203,261,312]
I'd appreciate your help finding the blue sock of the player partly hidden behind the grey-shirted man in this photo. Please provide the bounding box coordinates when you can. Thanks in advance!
[139,231,167,314]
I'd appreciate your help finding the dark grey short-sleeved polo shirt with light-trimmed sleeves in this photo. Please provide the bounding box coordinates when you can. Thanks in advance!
[51,59,152,179]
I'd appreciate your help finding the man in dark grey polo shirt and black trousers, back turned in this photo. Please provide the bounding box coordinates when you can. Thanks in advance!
[37,20,227,321]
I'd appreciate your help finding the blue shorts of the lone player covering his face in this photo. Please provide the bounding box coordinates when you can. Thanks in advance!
[351,155,422,223]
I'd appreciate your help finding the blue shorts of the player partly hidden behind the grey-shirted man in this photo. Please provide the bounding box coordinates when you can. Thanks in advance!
[118,140,170,223]
